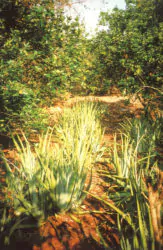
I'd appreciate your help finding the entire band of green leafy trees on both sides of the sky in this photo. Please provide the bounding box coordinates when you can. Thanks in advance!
[0,0,163,134]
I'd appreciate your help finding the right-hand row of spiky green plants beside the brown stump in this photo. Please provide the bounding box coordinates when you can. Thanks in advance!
[96,117,160,250]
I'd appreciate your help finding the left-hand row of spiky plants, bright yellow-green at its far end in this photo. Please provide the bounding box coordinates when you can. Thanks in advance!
[0,101,103,246]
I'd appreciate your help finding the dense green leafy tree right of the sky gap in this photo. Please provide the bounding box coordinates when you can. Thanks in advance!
[92,0,163,97]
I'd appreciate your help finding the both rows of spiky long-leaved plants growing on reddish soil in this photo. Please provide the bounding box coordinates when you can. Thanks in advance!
[1,99,161,250]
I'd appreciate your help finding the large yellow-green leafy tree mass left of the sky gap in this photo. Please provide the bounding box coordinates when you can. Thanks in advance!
[0,0,89,133]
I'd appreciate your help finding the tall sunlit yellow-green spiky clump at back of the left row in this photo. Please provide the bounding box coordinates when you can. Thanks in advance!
[52,101,104,210]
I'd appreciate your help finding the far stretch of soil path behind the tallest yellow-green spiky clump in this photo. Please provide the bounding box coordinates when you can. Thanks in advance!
[47,96,143,137]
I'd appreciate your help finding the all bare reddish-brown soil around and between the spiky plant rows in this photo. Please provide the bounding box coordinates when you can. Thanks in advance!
[1,96,145,250]
